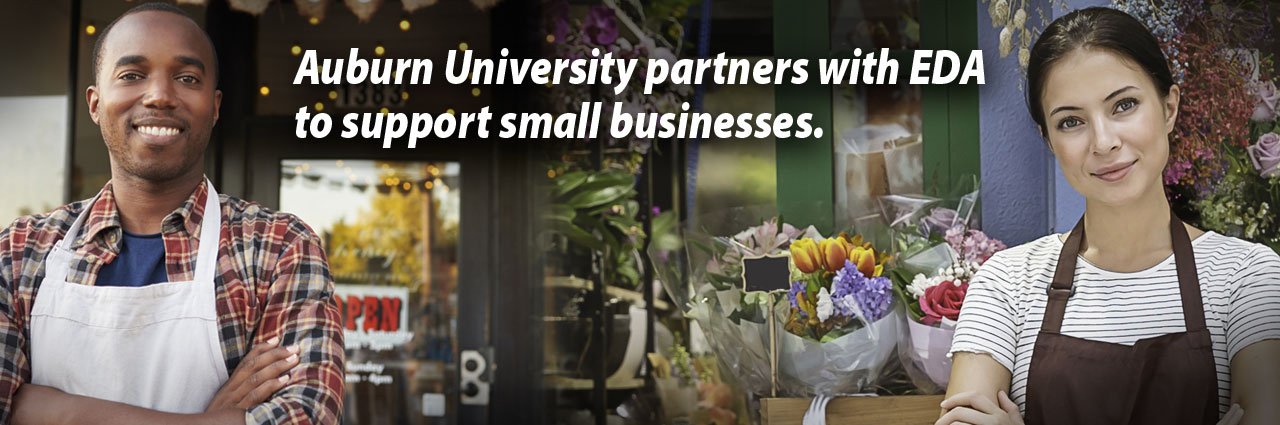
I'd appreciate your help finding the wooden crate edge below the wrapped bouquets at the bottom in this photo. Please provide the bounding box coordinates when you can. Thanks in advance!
[760,394,942,425]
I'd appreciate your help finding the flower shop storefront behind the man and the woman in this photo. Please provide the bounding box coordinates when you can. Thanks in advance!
[0,0,1277,424]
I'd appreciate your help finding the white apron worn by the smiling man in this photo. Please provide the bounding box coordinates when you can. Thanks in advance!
[31,179,227,413]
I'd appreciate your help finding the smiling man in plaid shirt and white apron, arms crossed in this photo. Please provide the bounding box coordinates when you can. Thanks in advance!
[0,4,343,425]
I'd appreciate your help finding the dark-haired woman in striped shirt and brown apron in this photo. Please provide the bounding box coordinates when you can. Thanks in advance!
[938,8,1280,424]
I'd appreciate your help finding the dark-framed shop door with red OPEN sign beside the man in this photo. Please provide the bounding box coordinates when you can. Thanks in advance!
[244,118,503,425]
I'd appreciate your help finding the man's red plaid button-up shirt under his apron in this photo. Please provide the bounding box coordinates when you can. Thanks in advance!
[0,182,344,424]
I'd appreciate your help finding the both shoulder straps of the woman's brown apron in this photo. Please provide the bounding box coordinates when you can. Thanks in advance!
[1041,211,1206,333]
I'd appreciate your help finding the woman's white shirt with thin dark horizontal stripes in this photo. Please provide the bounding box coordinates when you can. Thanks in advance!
[951,232,1280,413]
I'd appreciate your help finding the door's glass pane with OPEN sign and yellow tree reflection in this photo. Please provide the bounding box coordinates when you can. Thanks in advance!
[280,160,460,424]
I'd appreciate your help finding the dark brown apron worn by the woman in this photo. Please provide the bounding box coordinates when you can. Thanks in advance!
[1027,216,1219,425]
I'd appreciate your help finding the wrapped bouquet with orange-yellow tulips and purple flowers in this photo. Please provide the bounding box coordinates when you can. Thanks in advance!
[653,209,901,396]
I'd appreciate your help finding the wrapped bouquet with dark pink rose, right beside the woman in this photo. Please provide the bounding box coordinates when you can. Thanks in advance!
[882,191,1005,393]
